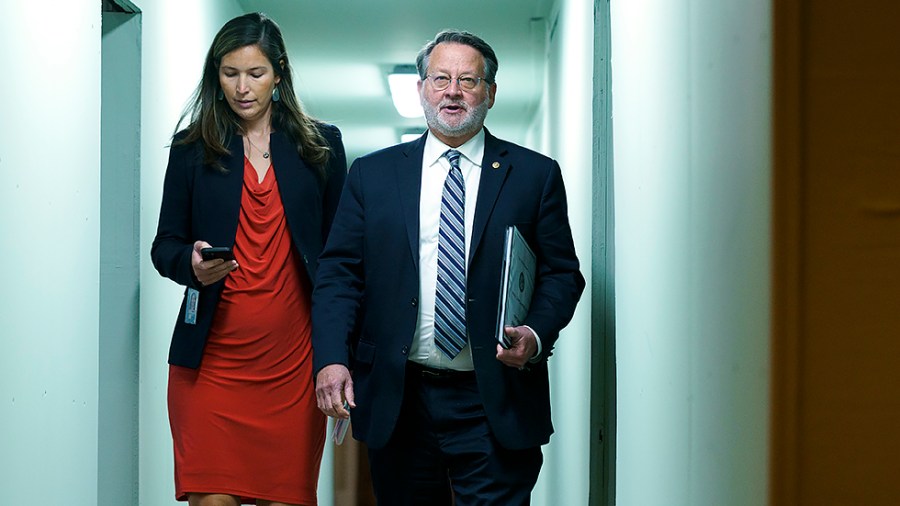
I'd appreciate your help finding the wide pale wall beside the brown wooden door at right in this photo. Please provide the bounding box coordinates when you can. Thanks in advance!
[610,0,771,506]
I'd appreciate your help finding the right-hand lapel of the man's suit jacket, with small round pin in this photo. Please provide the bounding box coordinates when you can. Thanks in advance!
[469,128,511,263]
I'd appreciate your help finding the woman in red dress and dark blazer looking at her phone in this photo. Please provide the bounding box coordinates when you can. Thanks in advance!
[151,13,346,506]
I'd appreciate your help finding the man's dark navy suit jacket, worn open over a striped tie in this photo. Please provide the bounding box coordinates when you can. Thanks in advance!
[313,127,584,449]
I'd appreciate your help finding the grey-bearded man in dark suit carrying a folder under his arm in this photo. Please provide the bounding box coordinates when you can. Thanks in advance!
[313,31,584,506]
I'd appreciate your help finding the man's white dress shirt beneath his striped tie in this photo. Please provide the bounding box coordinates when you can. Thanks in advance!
[409,129,484,371]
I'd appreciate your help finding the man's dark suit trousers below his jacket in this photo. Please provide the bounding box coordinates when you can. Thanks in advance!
[369,365,543,506]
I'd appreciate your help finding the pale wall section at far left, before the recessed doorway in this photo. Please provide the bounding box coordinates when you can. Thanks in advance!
[0,0,100,505]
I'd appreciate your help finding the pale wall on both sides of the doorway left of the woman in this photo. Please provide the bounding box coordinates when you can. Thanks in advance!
[0,0,262,506]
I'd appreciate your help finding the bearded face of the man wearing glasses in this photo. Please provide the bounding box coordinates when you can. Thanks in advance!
[418,42,497,147]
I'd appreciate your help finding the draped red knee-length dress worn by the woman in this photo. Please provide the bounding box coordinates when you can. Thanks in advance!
[168,159,326,505]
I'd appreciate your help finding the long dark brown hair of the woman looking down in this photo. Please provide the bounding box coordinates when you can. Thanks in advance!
[175,12,330,177]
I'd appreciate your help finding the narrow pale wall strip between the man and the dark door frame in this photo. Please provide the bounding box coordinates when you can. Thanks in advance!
[524,0,594,506]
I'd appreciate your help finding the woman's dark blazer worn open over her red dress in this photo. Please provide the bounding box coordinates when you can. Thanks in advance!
[150,125,347,368]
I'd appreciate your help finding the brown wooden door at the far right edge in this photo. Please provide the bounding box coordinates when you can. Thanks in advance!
[770,0,900,506]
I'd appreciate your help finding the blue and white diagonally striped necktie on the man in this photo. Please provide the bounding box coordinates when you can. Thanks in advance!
[434,149,466,359]
